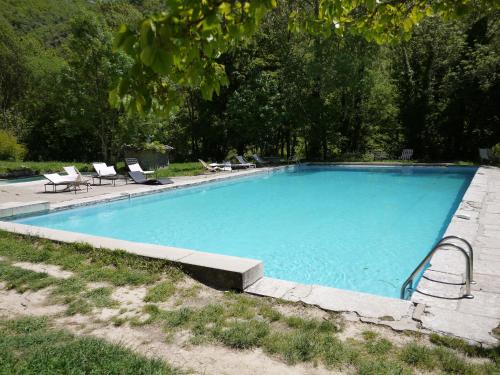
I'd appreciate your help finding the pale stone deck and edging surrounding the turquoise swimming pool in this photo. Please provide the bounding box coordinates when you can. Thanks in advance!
[0,167,500,345]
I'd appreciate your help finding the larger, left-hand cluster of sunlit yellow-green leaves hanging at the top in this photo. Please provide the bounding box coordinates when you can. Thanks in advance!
[110,0,276,114]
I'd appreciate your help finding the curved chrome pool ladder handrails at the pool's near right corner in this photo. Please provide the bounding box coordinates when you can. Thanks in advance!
[400,236,474,299]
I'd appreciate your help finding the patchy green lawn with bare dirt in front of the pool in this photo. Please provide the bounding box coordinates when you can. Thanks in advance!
[0,231,500,375]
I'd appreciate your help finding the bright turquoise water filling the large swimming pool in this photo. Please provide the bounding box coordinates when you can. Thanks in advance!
[12,166,476,297]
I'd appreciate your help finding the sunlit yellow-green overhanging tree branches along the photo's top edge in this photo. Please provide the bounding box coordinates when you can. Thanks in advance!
[110,0,498,113]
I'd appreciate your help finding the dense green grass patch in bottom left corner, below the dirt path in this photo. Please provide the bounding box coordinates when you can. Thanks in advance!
[0,317,179,375]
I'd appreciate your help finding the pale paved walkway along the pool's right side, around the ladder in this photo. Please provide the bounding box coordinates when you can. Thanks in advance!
[412,167,500,345]
